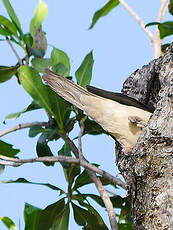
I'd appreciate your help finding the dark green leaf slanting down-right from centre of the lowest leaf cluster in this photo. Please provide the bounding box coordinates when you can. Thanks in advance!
[71,202,97,230]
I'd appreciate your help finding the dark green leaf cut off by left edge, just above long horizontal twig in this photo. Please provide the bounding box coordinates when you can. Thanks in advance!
[0,140,20,157]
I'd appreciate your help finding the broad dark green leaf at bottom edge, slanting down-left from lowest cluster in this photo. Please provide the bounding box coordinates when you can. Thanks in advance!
[35,198,65,230]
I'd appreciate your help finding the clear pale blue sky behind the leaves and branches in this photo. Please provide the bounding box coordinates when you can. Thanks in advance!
[0,0,171,230]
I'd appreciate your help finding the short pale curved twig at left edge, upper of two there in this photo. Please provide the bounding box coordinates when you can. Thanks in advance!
[0,121,49,137]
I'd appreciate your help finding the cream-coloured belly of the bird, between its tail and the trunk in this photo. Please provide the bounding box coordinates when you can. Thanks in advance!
[81,96,150,148]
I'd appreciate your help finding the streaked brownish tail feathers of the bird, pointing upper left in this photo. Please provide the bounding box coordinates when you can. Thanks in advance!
[43,69,93,110]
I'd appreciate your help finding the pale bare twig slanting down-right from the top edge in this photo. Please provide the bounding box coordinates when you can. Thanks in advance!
[119,0,153,41]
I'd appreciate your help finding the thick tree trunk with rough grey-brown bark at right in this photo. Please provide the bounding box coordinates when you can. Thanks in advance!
[116,44,173,230]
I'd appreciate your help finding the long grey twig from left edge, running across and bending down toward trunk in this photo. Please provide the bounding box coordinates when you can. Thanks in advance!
[0,155,126,190]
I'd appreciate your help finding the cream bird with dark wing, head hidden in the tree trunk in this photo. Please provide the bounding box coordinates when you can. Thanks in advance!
[43,68,154,152]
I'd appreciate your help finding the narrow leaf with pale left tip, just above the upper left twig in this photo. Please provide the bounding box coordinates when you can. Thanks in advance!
[5,101,41,120]
